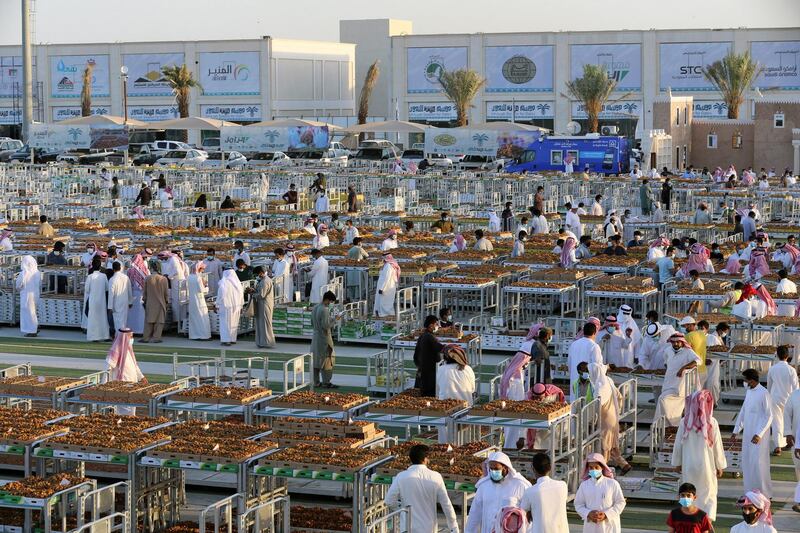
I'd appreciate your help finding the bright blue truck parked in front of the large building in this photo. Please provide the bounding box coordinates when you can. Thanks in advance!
[498,134,630,175]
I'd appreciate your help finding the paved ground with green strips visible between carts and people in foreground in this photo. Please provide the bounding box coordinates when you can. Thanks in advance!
[0,328,800,533]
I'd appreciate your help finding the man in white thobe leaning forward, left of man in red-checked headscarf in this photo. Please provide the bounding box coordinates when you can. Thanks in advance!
[654,333,700,426]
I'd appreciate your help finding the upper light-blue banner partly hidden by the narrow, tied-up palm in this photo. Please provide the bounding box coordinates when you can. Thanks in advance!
[50,55,111,98]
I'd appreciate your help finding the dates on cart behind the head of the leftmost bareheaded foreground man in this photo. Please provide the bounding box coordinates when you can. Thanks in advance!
[372,442,488,492]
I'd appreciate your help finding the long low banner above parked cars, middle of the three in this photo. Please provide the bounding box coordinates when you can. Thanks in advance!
[220,126,330,152]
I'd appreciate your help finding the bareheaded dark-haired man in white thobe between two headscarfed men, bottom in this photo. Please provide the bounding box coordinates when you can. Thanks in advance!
[520,453,569,533]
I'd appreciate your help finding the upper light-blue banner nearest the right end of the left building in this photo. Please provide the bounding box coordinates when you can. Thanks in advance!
[199,52,261,96]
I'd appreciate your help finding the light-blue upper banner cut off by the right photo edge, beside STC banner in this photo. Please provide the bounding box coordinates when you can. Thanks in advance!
[750,41,800,91]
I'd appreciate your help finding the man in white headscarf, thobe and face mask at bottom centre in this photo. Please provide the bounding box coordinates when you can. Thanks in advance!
[462,452,531,533]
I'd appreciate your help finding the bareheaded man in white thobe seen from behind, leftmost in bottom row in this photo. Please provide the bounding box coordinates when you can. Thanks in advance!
[384,444,459,533]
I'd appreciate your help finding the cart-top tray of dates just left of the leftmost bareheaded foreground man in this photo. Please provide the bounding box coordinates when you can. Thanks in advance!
[255,444,392,481]
